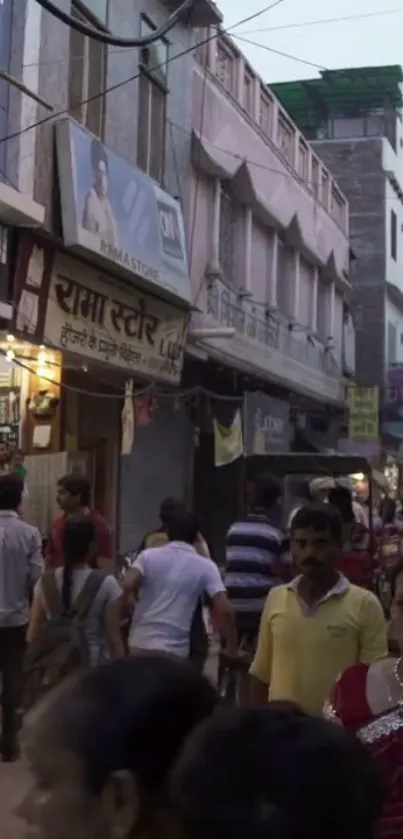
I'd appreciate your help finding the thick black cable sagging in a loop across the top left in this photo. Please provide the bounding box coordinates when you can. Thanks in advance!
[36,0,198,48]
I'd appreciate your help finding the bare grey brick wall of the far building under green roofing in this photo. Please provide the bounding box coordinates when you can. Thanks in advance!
[312,138,386,387]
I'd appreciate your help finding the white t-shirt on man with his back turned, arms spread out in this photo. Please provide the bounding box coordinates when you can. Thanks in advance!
[129,542,225,658]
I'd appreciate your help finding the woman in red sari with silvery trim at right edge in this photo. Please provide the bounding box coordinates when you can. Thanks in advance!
[326,561,403,839]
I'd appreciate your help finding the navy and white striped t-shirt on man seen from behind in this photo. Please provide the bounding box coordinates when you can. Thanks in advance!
[224,514,291,633]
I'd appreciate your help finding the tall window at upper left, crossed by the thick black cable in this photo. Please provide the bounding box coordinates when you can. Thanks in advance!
[69,5,106,137]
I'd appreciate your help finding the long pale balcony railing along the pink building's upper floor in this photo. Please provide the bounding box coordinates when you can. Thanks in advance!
[194,279,344,404]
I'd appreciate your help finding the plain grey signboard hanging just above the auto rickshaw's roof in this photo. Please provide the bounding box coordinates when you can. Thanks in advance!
[244,392,290,455]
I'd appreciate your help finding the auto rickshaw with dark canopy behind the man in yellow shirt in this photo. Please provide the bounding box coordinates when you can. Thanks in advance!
[244,453,387,607]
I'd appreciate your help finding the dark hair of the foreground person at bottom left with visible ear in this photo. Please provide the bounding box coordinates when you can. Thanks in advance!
[43,653,217,798]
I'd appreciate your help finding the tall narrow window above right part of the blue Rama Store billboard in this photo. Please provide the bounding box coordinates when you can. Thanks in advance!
[137,19,169,183]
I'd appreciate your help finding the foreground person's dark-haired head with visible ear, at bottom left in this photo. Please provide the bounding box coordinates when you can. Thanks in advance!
[17,653,217,839]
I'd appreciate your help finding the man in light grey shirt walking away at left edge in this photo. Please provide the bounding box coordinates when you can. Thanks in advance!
[0,474,43,762]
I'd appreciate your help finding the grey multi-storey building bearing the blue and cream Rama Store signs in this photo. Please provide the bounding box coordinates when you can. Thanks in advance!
[0,0,221,550]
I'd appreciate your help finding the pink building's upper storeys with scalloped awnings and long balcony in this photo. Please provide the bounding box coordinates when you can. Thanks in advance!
[188,33,354,406]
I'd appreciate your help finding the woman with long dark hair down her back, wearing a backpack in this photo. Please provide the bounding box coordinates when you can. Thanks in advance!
[27,516,124,665]
